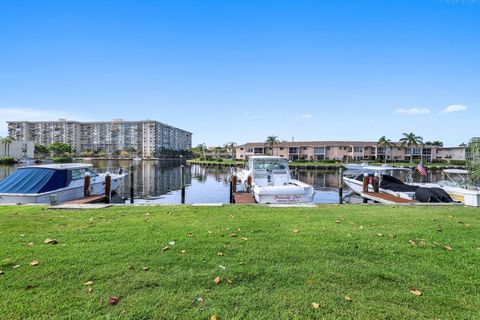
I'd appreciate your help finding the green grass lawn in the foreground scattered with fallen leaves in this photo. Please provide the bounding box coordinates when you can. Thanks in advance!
[0,205,480,319]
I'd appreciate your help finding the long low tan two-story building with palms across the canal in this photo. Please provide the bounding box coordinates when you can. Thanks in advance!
[236,141,465,161]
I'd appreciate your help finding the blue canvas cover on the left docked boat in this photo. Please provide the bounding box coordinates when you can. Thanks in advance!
[0,167,69,194]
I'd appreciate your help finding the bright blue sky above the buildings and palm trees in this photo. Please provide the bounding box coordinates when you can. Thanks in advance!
[0,0,480,146]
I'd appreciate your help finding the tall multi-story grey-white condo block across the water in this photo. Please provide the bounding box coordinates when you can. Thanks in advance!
[7,119,192,158]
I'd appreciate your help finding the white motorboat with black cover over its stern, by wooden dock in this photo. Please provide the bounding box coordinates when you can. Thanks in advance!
[343,166,454,203]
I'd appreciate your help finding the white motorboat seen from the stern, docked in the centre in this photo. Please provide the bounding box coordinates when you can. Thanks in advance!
[236,156,315,204]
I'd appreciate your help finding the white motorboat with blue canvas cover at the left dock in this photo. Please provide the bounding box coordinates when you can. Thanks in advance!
[0,163,126,204]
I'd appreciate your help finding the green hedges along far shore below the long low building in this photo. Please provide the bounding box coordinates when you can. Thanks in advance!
[187,159,465,170]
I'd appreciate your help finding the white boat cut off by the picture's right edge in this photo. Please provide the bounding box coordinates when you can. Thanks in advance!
[417,169,480,207]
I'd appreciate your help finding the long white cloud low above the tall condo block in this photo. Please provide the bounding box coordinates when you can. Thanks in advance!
[0,108,87,136]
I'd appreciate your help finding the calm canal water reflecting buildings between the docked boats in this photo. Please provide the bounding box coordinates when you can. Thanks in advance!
[0,160,444,204]
